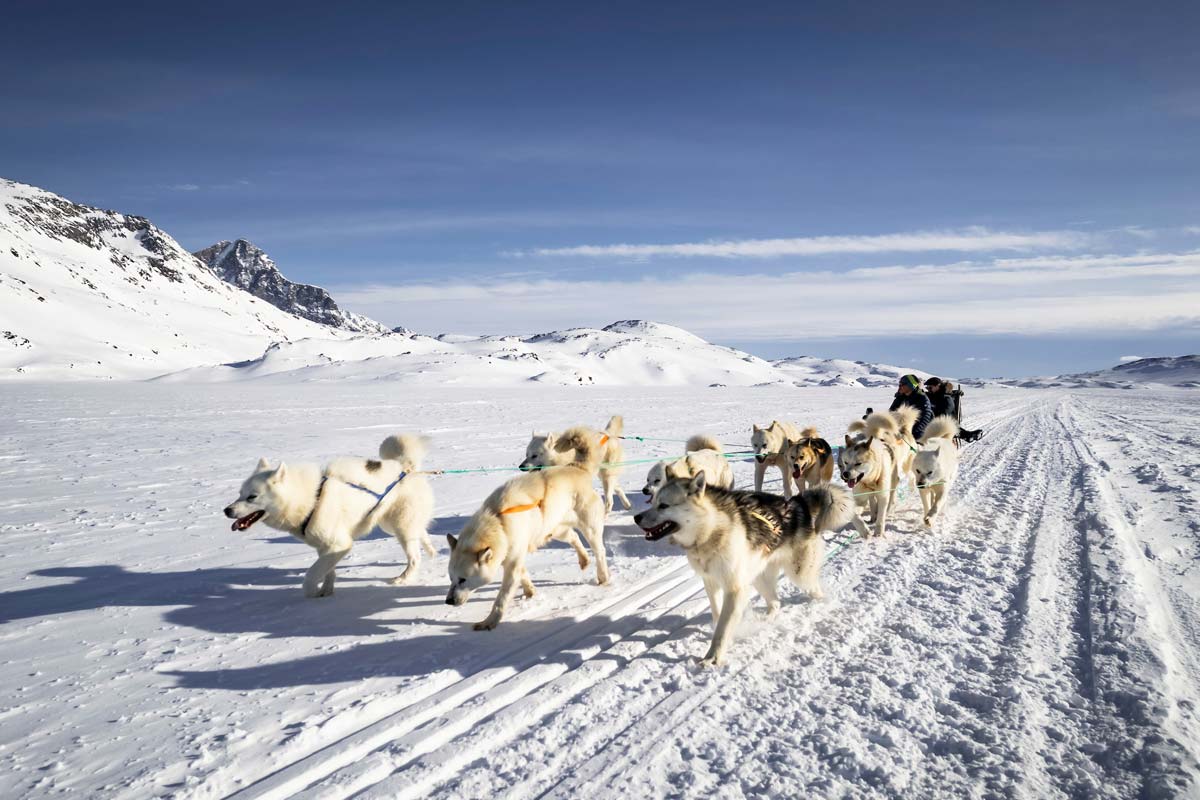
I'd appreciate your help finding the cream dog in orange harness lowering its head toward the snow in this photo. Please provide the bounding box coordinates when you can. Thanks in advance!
[446,428,608,631]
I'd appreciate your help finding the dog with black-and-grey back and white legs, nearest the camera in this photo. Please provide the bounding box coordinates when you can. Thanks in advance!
[634,473,857,667]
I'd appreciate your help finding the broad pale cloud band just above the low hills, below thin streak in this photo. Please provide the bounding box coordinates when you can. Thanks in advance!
[335,251,1200,341]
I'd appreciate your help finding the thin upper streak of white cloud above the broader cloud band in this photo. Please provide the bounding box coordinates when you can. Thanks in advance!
[506,227,1093,259]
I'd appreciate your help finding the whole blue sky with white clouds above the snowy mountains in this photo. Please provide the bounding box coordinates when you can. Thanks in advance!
[0,1,1200,375]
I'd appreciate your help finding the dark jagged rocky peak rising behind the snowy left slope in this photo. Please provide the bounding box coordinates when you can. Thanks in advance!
[193,239,392,333]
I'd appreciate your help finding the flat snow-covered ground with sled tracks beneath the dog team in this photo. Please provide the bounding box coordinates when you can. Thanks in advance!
[0,381,1200,798]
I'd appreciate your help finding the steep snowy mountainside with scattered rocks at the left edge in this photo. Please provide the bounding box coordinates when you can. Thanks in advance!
[0,179,348,379]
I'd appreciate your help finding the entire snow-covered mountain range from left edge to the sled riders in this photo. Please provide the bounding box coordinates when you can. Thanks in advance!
[0,180,924,386]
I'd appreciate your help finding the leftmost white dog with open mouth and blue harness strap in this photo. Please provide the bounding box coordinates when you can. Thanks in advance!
[224,434,436,597]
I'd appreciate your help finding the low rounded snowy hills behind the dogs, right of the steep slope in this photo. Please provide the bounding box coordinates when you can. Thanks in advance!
[170,320,921,386]
